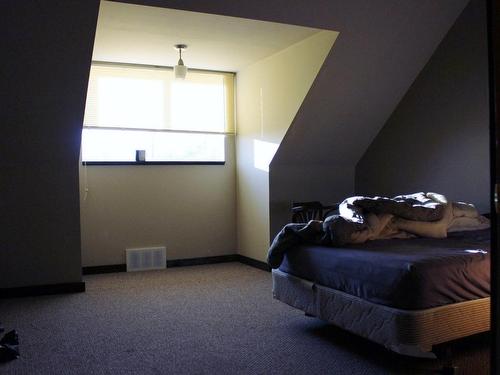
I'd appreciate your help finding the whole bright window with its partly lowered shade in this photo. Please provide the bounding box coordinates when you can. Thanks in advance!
[82,63,234,163]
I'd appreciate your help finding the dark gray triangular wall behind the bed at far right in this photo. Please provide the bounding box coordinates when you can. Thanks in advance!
[355,0,490,216]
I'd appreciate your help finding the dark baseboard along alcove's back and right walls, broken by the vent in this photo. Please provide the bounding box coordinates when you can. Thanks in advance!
[82,254,271,275]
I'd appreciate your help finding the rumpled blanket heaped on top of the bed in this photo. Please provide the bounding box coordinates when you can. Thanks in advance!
[267,192,490,268]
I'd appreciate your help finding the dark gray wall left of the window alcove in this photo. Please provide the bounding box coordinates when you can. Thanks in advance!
[0,0,99,288]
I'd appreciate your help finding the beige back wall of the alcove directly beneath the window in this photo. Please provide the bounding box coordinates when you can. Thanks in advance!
[80,136,236,266]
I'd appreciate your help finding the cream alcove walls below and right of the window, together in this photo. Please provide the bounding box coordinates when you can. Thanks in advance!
[80,31,337,266]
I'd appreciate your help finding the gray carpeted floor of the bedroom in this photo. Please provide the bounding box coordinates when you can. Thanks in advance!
[0,263,489,375]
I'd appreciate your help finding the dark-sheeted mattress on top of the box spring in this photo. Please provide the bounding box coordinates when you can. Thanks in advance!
[279,230,490,310]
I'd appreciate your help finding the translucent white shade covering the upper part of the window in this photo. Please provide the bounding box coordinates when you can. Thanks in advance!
[84,63,234,133]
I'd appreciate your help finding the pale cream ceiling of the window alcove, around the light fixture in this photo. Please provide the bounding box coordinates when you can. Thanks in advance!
[93,1,320,72]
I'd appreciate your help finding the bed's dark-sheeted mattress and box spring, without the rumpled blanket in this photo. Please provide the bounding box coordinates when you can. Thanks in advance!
[272,201,490,358]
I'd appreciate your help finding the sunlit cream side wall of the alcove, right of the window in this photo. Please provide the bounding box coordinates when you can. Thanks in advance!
[236,31,338,261]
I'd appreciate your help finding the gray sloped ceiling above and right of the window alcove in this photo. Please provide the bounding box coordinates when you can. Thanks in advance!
[117,0,467,170]
